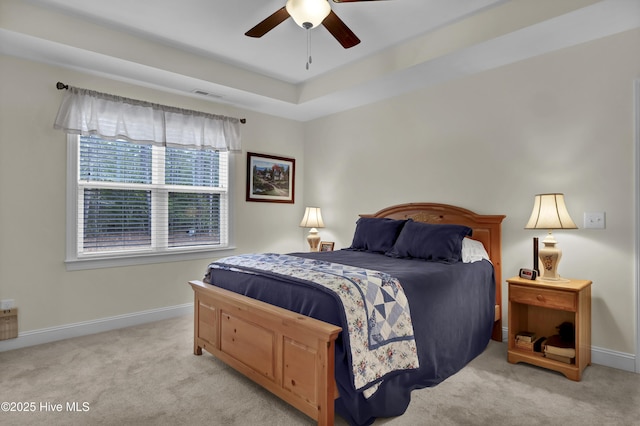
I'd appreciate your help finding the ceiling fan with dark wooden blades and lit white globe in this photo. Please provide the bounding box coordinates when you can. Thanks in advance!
[245,0,378,49]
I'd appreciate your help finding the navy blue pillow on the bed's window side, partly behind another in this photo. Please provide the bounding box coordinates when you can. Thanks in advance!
[349,217,407,253]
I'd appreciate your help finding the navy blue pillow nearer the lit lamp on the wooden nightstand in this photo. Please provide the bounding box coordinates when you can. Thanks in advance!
[385,221,472,263]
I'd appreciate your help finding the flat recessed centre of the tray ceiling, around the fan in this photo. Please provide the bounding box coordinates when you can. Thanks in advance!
[18,0,510,83]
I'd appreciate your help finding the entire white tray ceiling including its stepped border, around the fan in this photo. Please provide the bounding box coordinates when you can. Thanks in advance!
[0,0,640,121]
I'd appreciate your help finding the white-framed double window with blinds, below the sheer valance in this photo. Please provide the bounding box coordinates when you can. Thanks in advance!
[67,136,229,268]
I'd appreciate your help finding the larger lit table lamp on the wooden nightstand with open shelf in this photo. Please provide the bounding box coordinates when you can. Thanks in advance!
[525,193,578,282]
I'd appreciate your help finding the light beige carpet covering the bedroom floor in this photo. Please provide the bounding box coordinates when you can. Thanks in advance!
[0,317,640,426]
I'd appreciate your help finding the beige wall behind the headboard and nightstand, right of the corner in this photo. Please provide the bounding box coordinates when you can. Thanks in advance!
[304,26,640,354]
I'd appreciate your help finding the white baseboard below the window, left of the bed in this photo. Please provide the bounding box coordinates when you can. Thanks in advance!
[0,303,193,352]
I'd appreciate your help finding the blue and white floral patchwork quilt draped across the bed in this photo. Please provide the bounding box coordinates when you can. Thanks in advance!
[209,253,419,395]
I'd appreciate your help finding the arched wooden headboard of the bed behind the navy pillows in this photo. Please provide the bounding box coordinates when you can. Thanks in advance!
[360,203,506,341]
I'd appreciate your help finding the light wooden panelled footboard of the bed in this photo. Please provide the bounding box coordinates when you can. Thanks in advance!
[189,281,342,425]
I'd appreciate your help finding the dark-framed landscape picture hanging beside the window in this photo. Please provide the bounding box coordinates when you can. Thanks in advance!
[247,152,296,204]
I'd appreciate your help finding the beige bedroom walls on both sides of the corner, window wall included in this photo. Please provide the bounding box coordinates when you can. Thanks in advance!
[0,30,640,360]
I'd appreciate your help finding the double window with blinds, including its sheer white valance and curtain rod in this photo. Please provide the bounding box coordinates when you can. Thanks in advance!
[53,83,243,270]
